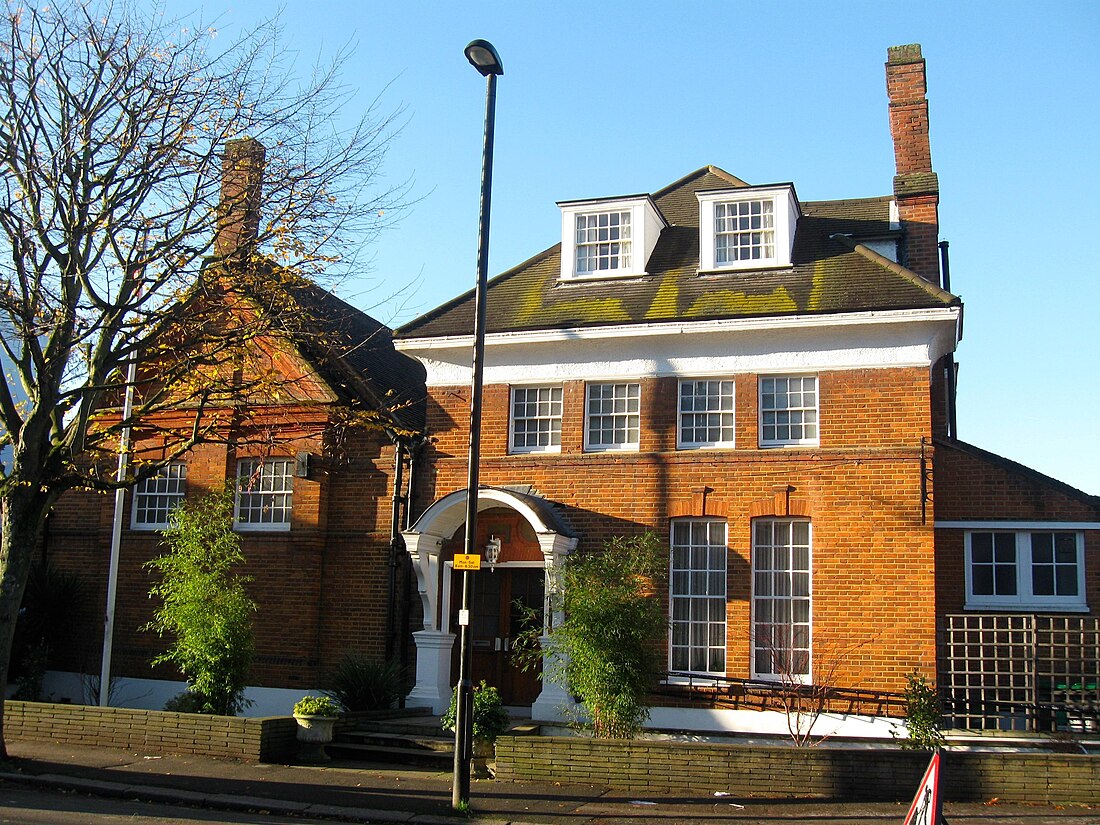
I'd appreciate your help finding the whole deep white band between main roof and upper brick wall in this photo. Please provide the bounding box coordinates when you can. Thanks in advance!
[395,307,958,386]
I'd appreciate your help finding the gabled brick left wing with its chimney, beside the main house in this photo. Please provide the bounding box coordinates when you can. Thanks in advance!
[42,140,424,714]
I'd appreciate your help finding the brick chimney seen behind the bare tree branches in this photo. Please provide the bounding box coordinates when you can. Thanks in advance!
[213,138,265,261]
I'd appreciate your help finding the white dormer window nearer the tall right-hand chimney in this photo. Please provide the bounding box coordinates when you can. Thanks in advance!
[696,184,801,272]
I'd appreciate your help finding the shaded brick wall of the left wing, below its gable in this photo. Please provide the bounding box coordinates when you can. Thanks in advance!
[43,407,404,690]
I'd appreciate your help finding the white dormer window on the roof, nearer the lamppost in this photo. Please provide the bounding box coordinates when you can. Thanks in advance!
[558,195,668,281]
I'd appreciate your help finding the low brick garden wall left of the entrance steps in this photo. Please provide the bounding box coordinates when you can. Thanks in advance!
[3,702,298,761]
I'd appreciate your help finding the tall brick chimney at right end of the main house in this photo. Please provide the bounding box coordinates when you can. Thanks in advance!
[887,43,939,285]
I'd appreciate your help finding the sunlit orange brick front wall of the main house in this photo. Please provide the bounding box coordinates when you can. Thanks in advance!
[420,369,935,691]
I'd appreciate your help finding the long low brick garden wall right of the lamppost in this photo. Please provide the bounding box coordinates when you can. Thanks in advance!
[496,736,1100,803]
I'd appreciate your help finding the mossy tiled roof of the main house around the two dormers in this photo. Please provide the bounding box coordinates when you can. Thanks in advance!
[395,166,958,339]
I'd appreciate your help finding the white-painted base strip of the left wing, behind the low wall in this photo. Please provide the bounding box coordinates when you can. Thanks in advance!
[42,670,321,717]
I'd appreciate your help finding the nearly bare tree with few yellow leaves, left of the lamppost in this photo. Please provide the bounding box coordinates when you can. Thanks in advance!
[0,0,404,754]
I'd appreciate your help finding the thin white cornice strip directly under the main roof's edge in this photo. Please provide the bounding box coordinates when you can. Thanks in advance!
[394,306,961,352]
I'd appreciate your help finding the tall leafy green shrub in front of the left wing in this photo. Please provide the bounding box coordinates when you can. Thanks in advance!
[144,487,256,716]
